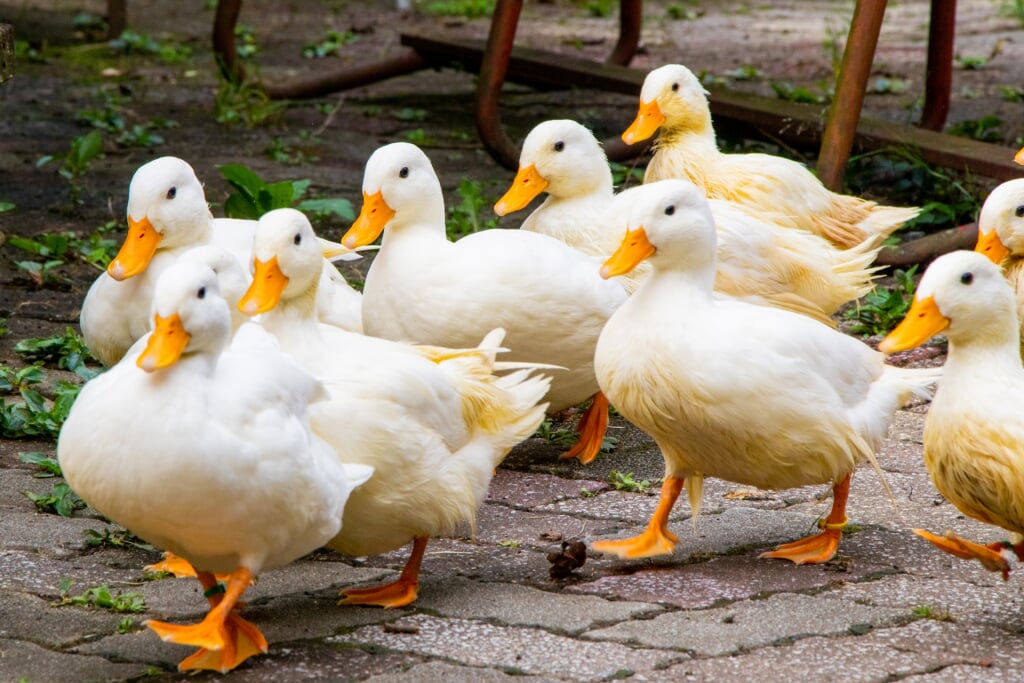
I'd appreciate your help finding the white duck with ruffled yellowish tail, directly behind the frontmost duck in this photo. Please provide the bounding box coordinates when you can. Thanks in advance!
[240,209,549,607]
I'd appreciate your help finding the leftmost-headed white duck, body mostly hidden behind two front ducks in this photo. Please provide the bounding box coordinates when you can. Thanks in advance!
[81,157,361,367]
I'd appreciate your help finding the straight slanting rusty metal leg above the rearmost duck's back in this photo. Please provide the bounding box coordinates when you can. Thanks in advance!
[817,0,886,191]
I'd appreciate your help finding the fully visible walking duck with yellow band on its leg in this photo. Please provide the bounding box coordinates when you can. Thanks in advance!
[592,180,938,564]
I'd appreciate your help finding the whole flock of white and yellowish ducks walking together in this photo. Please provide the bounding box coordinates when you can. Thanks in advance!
[57,65,1024,672]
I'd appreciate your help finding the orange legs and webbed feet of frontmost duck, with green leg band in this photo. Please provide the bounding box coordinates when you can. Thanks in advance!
[145,567,267,673]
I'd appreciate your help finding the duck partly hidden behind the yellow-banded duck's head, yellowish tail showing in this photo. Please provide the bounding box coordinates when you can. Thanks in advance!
[495,120,881,325]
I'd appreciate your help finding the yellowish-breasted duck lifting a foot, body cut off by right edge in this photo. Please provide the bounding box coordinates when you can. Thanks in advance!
[880,251,1024,579]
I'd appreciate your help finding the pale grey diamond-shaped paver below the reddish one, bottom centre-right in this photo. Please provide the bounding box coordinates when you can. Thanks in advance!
[584,594,909,656]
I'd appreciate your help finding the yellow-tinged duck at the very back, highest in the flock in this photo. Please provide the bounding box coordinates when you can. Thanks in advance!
[623,65,920,248]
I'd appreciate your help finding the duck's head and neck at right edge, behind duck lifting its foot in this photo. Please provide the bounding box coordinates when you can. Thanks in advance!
[974,178,1024,356]
